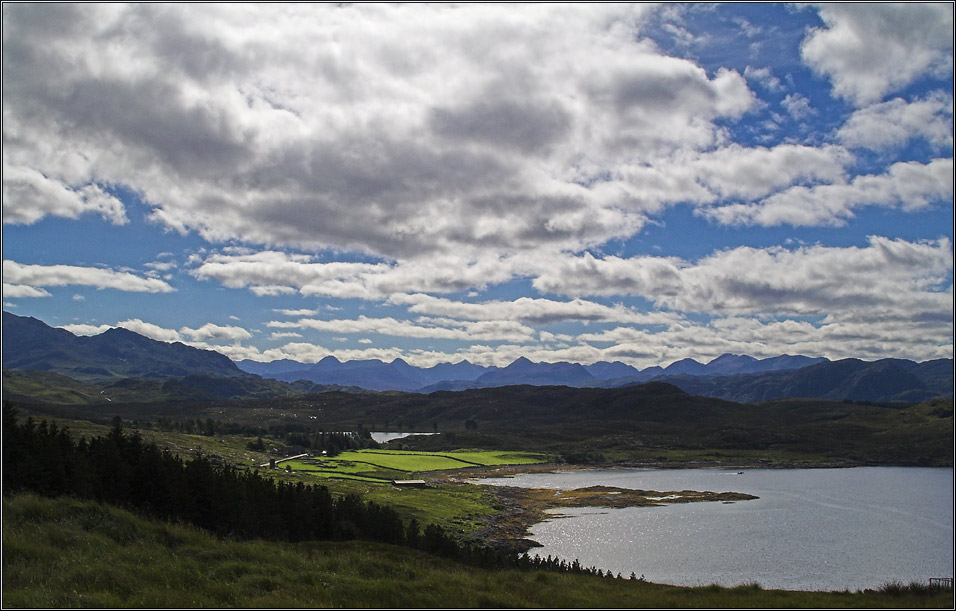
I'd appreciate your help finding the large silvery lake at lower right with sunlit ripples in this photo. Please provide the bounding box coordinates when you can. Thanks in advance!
[481,467,953,590]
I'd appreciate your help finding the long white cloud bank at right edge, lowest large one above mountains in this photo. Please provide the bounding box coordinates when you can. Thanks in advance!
[534,236,953,321]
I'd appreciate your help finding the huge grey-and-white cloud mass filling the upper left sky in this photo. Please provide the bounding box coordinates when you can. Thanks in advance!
[3,3,756,260]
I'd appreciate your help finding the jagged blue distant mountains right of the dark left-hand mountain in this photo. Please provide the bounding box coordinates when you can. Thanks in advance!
[237,354,953,403]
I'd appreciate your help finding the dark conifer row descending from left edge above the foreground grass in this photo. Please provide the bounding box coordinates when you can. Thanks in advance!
[3,402,624,576]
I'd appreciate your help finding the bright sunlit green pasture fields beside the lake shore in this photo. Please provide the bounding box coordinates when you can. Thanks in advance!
[278,450,547,482]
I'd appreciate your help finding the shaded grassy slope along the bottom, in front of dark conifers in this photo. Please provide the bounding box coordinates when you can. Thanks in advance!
[3,495,953,608]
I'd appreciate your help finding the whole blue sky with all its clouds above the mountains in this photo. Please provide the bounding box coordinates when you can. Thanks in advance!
[2,3,954,369]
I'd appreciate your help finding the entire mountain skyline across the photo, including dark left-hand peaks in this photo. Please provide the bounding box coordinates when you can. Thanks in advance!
[3,312,953,402]
